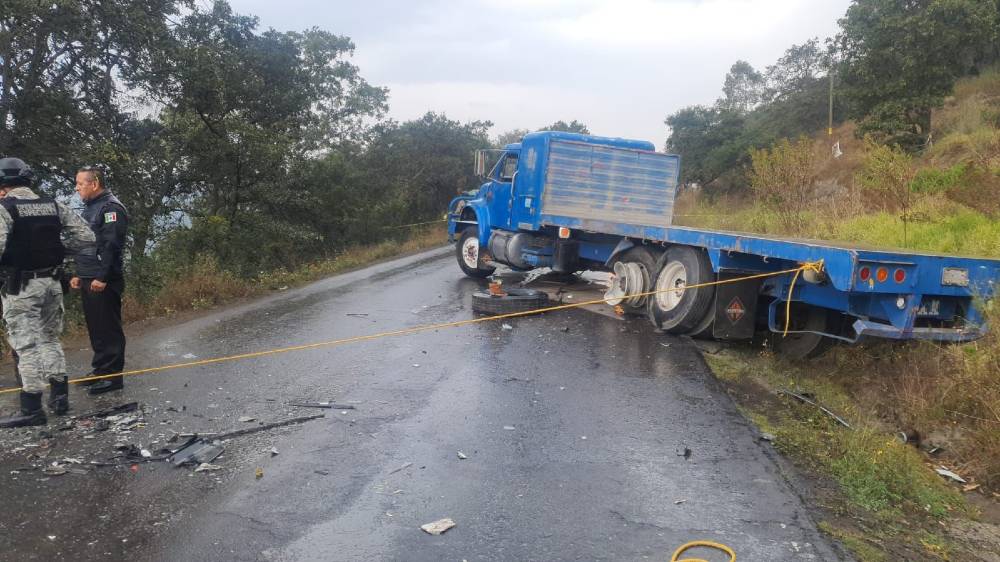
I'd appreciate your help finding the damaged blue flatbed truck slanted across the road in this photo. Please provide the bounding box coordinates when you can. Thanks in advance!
[448,131,1000,358]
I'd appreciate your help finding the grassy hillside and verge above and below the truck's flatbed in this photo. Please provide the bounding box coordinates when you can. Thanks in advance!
[676,48,1000,561]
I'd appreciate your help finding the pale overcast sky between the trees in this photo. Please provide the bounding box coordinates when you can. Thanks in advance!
[229,0,850,147]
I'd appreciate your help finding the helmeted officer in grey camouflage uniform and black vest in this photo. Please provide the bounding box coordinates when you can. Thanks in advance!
[0,158,94,427]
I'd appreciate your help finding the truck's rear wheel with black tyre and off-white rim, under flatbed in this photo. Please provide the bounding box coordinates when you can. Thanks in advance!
[647,246,716,334]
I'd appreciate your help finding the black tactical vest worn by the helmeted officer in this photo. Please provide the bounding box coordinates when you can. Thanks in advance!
[0,197,66,271]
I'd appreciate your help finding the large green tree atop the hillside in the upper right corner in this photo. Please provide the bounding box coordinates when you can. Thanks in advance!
[838,0,1000,148]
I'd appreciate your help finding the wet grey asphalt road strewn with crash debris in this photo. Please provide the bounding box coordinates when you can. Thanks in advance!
[0,251,839,561]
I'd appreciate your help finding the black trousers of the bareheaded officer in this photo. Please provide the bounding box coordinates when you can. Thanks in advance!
[80,279,125,375]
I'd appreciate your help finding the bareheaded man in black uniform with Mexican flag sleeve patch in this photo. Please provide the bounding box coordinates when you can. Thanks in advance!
[70,167,128,394]
